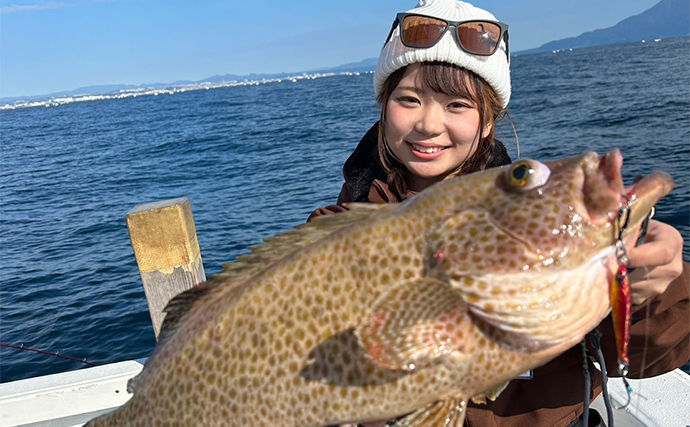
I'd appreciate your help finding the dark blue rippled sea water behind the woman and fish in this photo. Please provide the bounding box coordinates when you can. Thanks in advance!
[0,38,690,382]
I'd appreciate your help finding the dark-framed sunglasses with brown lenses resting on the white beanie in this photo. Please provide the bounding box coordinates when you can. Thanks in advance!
[384,12,510,62]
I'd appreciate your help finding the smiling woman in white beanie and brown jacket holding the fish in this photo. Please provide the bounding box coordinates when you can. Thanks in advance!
[310,0,690,426]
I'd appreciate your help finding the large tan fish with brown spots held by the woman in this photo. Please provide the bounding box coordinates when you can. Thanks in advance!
[83,150,673,427]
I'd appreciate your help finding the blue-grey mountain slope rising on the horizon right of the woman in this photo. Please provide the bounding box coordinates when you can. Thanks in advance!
[515,0,690,55]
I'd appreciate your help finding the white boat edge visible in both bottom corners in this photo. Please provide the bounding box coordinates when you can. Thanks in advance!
[0,360,690,427]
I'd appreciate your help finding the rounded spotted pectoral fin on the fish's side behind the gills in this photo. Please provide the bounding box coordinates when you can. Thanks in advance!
[355,278,470,370]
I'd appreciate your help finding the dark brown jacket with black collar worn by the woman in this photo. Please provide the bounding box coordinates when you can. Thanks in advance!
[310,125,690,427]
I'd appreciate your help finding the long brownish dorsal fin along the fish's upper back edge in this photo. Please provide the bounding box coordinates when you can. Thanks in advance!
[128,203,400,391]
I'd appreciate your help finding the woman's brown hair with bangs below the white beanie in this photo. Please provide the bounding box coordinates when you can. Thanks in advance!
[378,62,505,199]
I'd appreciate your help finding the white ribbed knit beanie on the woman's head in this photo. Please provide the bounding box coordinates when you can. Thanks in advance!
[374,0,510,108]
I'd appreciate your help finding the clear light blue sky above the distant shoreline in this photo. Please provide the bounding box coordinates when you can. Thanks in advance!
[0,0,658,97]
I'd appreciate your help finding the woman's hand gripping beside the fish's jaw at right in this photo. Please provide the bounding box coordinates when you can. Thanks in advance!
[628,220,683,305]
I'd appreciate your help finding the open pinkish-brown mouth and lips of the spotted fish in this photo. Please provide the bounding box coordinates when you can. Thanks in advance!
[583,148,674,235]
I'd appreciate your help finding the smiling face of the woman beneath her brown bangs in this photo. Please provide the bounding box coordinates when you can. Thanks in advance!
[384,64,491,191]
